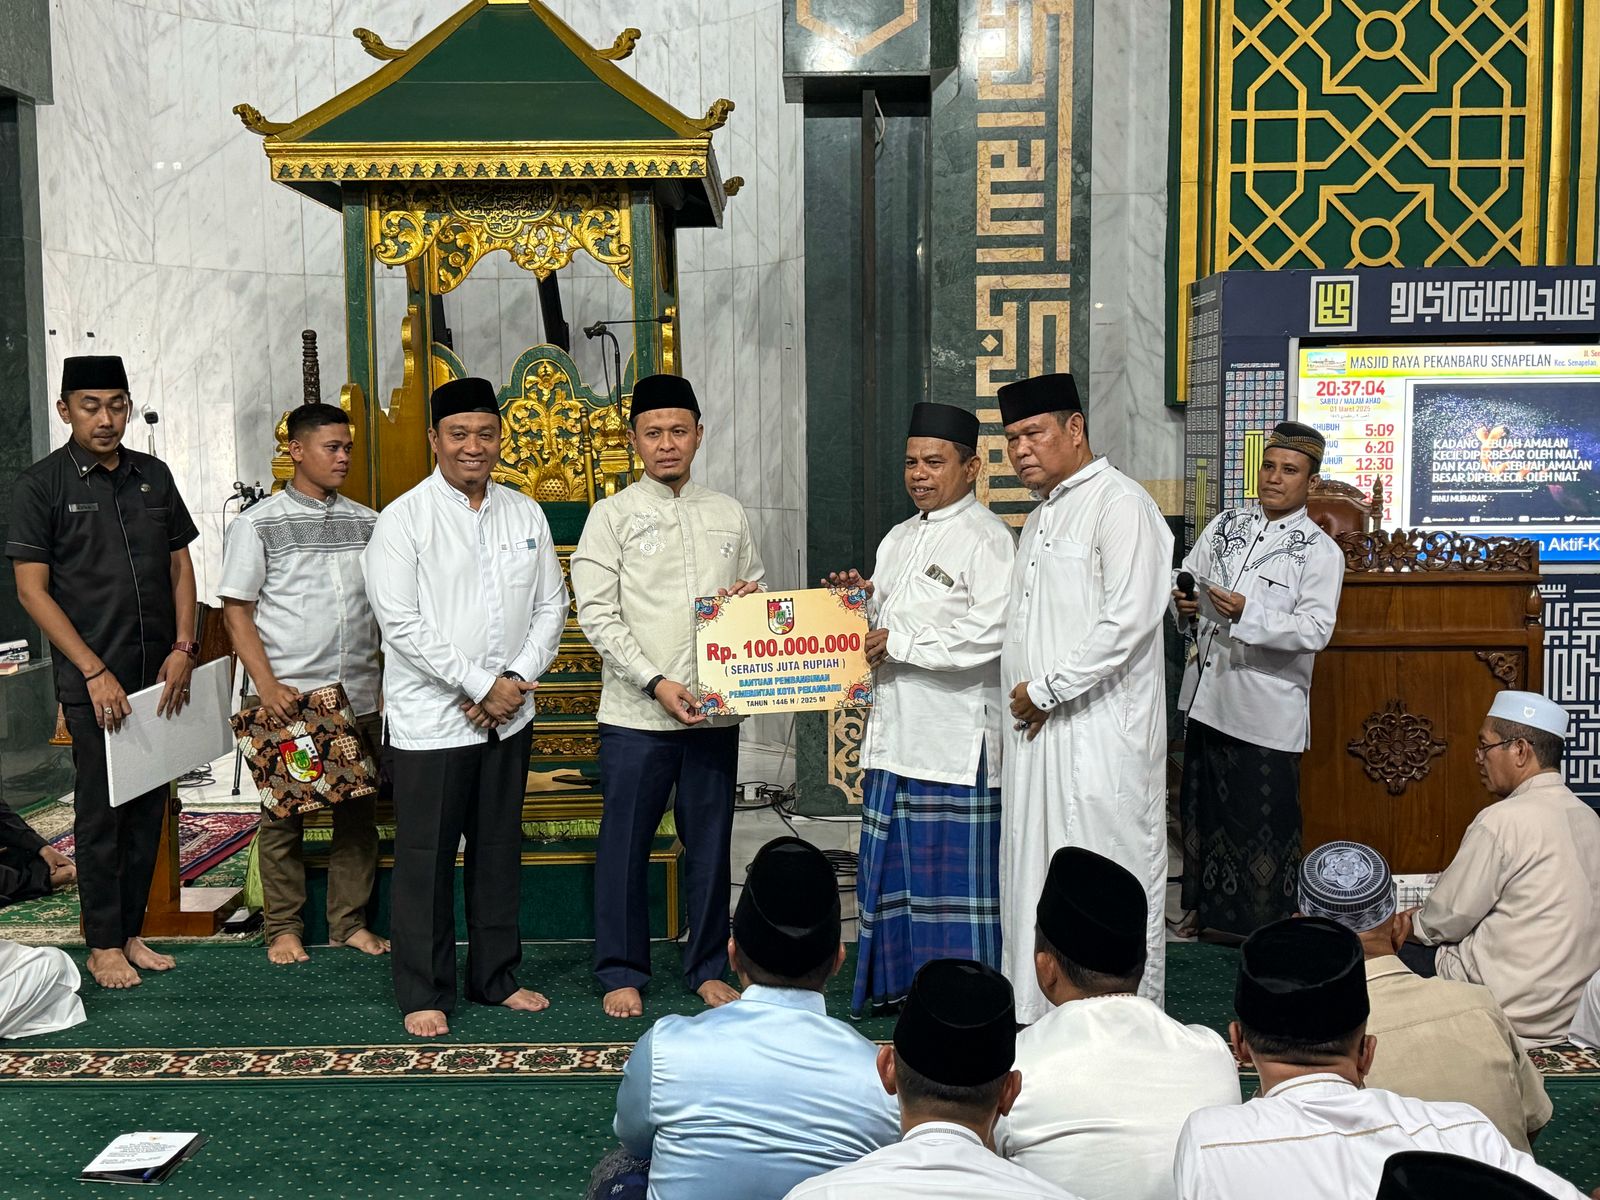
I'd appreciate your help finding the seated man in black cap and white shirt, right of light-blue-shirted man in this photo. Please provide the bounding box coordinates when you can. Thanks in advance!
[787,960,1075,1200]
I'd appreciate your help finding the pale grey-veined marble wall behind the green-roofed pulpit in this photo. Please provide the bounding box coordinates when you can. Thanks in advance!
[40,0,805,630]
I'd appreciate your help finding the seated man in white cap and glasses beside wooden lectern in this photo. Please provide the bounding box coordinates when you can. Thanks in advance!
[1400,691,1600,1048]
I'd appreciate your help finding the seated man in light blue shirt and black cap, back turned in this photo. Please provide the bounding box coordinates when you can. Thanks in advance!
[592,837,899,1200]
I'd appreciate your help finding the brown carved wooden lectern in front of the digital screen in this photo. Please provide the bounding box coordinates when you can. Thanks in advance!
[1301,530,1544,872]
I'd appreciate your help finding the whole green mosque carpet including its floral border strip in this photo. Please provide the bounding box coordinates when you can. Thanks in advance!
[0,942,1600,1200]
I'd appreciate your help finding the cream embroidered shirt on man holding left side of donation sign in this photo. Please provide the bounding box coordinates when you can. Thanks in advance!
[571,475,765,731]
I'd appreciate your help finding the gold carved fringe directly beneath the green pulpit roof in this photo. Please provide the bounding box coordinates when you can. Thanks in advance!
[373,184,634,293]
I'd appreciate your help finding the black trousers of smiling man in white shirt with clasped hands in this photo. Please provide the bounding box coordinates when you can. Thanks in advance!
[389,722,533,1013]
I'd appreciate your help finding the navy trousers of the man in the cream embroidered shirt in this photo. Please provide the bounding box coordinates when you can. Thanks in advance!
[595,725,739,992]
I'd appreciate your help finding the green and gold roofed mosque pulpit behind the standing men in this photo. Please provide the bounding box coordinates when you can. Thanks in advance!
[234,0,741,936]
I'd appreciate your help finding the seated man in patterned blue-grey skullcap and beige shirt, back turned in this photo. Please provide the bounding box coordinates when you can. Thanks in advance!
[1299,842,1550,1150]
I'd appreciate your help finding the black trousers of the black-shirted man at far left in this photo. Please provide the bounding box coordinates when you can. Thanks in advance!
[61,704,166,950]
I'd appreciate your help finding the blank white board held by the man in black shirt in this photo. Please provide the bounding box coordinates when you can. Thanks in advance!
[102,658,234,808]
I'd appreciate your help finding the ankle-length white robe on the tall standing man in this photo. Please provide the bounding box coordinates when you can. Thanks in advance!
[1000,458,1173,1024]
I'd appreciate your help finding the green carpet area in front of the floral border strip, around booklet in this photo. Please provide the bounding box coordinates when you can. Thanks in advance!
[0,1080,616,1200]
